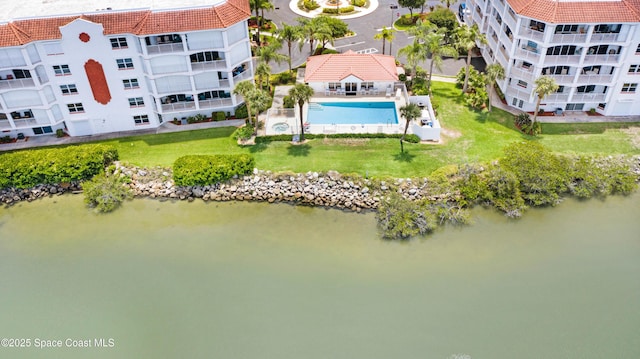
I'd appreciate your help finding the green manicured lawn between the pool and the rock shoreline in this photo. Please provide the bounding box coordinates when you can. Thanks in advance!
[51,82,640,177]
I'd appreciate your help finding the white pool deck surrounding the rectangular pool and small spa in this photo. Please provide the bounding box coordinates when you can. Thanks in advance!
[265,92,411,135]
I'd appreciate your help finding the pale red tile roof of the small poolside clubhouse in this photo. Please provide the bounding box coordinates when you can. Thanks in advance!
[304,51,398,82]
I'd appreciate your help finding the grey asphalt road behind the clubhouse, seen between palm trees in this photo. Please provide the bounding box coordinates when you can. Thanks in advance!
[258,0,485,76]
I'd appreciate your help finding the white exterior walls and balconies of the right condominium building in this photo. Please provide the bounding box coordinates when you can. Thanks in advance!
[464,0,640,116]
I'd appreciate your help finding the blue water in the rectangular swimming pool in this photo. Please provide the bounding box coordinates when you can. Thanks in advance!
[307,102,398,125]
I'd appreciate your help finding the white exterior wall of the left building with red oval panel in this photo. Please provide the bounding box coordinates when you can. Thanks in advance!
[0,10,253,137]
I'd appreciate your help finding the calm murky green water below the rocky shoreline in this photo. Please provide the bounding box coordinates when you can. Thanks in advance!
[0,195,640,359]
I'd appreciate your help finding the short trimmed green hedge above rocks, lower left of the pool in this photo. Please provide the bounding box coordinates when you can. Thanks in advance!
[173,154,255,186]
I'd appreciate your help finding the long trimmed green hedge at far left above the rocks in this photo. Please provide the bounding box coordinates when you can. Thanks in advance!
[0,145,118,188]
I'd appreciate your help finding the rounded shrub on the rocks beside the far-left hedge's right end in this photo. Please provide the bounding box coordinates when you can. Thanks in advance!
[82,173,132,213]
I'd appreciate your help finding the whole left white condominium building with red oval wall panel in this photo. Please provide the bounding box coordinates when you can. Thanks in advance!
[0,0,253,137]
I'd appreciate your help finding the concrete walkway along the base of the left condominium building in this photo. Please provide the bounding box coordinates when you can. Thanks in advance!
[0,120,244,152]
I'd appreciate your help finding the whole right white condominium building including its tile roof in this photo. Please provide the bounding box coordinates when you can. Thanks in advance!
[464,0,640,116]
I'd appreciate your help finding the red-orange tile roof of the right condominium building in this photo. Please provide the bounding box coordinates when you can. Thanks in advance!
[507,0,640,24]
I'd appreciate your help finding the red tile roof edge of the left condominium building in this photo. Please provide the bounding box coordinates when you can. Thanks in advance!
[0,0,251,47]
